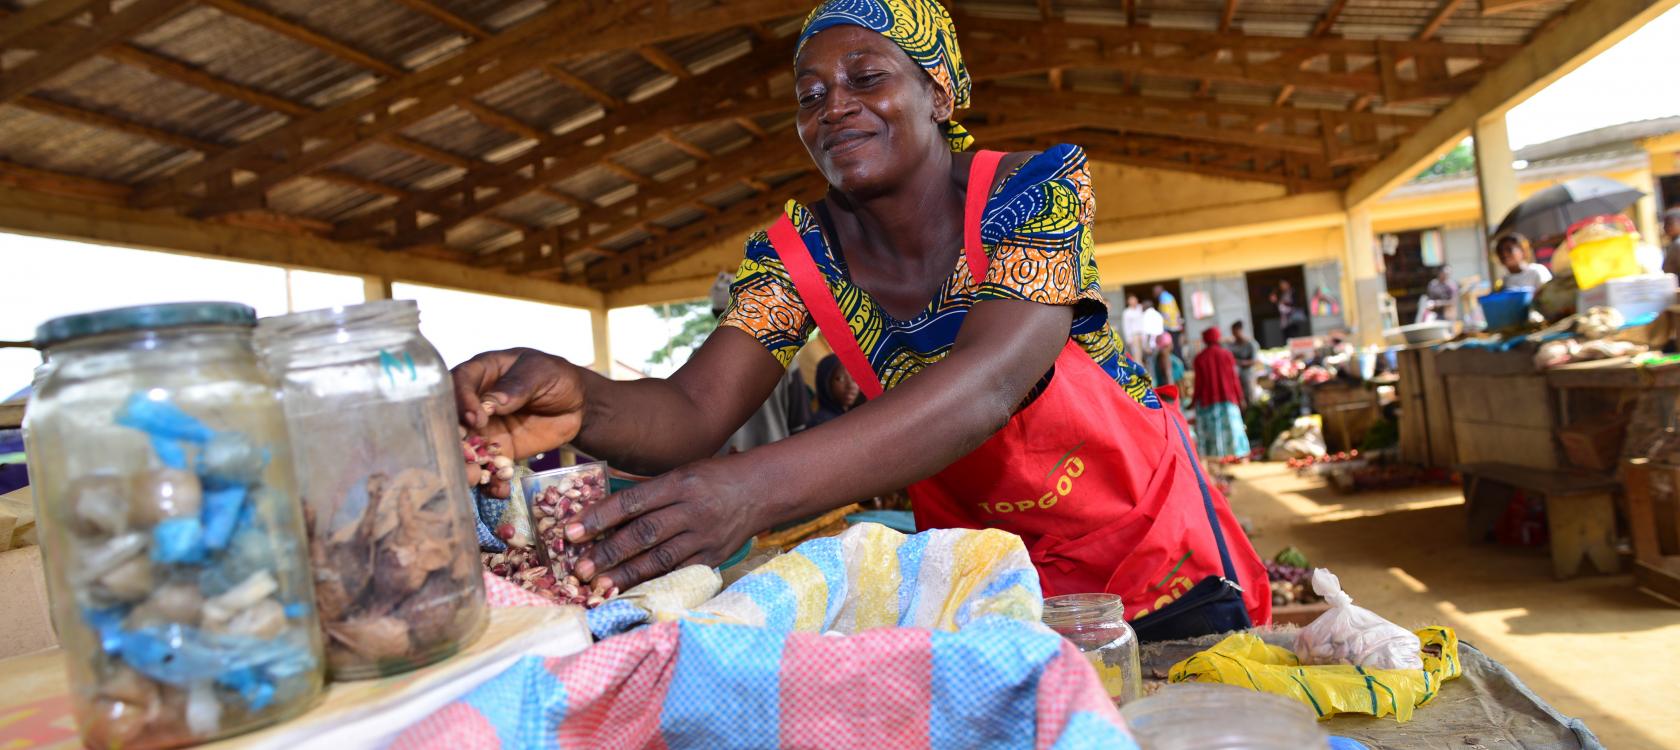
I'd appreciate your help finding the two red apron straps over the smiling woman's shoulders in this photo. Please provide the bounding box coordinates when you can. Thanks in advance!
[766,151,1003,399]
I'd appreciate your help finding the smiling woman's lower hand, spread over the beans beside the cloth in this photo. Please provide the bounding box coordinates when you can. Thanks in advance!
[566,454,769,590]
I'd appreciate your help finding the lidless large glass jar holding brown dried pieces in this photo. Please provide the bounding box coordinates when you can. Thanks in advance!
[257,301,489,679]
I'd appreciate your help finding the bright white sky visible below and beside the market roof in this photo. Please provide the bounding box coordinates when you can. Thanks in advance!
[0,8,1680,397]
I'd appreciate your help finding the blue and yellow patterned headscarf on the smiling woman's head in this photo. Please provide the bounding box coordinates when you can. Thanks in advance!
[793,0,974,151]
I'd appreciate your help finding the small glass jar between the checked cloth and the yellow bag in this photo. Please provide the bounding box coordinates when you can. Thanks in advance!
[1043,594,1144,706]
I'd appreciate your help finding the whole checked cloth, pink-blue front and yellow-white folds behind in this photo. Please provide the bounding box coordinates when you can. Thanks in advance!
[393,525,1136,750]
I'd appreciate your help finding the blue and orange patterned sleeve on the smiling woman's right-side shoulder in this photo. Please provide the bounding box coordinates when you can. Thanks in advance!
[976,146,1107,314]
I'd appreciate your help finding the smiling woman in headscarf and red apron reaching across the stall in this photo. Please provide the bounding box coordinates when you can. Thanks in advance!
[455,0,1270,639]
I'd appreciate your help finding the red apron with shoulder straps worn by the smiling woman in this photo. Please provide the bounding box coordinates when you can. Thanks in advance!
[769,151,1272,624]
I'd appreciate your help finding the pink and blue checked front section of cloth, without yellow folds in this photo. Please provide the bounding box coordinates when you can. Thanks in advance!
[393,617,1136,750]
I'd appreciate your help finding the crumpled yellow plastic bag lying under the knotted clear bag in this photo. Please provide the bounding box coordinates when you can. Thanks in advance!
[1168,627,1463,721]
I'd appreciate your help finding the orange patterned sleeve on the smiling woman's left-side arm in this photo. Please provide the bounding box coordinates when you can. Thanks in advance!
[717,202,813,367]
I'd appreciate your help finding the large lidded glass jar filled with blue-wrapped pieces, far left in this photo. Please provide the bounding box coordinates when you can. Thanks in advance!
[27,303,323,750]
